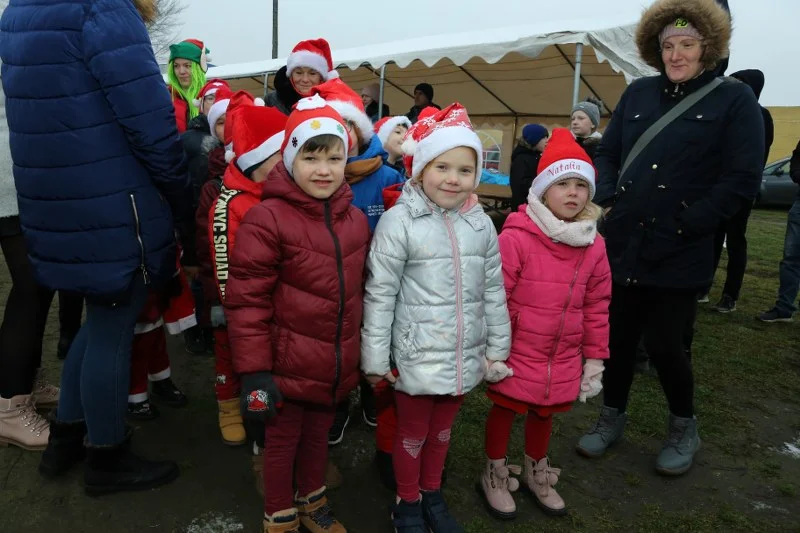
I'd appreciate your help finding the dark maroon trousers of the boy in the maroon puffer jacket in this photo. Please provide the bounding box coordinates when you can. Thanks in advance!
[264,399,336,515]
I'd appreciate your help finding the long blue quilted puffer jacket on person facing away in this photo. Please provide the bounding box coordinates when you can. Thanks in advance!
[0,0,190,300]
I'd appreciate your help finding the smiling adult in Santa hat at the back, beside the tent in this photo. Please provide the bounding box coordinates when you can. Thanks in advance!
[264,39,339,115]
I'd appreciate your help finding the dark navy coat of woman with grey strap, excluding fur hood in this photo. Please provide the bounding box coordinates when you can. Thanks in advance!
[594,72,764,289]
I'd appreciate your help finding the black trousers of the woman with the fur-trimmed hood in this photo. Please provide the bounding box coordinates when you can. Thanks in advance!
[603,283,697,418]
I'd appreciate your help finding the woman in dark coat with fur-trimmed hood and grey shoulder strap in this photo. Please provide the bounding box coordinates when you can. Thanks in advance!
[577,0,764,475]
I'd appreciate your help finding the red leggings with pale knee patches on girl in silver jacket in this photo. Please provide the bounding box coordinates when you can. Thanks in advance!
[392,391,464,502]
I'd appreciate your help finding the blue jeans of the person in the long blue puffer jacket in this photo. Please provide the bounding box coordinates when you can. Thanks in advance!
[56,275,148,446]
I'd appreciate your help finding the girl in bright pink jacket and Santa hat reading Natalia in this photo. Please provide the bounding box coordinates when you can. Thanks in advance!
[481,129,611,518]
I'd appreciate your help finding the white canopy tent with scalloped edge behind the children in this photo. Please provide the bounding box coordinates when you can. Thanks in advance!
[202,18,654,169]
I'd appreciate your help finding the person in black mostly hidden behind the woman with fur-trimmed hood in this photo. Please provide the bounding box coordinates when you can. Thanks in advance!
[698,70,775,313]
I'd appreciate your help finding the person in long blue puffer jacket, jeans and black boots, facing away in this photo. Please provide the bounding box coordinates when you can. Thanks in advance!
[0,0,191,494]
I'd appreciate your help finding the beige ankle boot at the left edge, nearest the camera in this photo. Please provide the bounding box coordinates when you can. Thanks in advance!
[0,394,50,451]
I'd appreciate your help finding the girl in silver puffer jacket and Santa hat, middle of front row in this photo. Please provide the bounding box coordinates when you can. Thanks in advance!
[361,103,511,533]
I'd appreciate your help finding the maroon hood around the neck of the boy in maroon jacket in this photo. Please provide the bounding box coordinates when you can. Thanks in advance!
[261,161,353,219]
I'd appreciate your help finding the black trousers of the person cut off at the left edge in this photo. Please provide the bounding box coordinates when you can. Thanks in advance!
[0,233,53,399]
